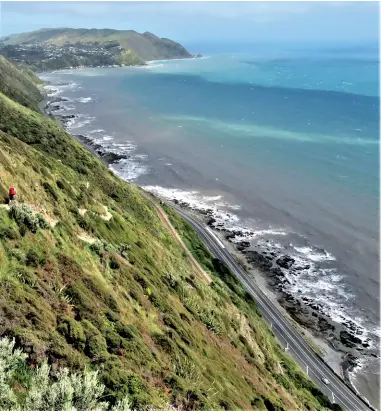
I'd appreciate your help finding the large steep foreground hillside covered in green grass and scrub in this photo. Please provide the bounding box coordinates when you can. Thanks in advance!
[0,56,333,411]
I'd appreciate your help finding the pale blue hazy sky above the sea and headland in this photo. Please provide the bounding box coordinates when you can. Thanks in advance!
[0,1,379,45]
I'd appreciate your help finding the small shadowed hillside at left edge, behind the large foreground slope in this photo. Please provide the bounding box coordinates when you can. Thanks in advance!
[0,56,41,109]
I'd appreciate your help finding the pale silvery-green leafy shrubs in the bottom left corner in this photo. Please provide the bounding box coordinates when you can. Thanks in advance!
[0,338,131,411]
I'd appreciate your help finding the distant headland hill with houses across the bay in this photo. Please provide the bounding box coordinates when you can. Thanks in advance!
[0,28,192,70]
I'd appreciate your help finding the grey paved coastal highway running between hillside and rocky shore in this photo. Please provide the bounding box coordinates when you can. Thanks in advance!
[168,204,373,411]
